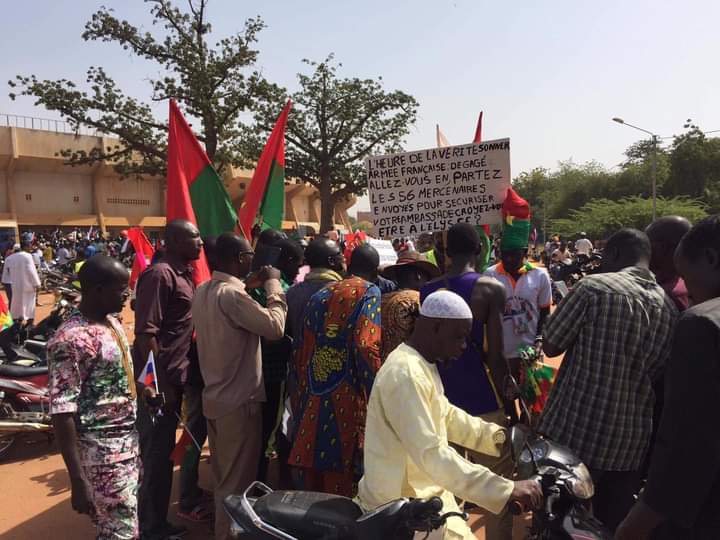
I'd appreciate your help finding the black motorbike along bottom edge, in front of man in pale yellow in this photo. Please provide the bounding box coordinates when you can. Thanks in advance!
[223,482,467,540]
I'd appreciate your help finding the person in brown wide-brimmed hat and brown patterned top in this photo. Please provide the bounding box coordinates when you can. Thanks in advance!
[380,251,440,361]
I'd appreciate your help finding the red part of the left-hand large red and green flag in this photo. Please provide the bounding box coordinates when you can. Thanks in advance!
[167,100,210,285]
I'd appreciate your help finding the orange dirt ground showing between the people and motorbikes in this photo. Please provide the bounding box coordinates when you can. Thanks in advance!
[0,295,556,540]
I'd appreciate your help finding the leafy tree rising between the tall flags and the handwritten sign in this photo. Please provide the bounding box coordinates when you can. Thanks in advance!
[245,54,418,232]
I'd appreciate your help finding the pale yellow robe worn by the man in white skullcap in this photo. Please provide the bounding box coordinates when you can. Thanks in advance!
[358,343,513,540]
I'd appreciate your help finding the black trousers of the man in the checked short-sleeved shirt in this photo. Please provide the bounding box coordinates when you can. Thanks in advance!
[590,469,642,533]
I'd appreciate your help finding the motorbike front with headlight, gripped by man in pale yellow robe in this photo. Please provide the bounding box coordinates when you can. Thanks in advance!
[509,377,613,540]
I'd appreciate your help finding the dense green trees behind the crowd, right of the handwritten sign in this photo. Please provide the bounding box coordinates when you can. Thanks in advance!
[513,126,720,237]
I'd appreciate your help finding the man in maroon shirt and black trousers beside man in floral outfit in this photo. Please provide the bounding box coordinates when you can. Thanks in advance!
[133,220,203,540]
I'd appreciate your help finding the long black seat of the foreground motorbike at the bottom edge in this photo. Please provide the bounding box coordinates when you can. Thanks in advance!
[253,491,363,540]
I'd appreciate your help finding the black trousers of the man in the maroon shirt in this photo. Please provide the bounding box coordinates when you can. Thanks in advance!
[137,387,182,536]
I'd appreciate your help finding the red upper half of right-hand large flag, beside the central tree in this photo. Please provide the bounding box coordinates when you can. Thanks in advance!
[238,100,292,238]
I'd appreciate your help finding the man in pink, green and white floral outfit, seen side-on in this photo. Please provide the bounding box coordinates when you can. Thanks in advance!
[48,255,140,540]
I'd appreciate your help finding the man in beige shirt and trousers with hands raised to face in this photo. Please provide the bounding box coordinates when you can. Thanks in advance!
[192,233,287,540]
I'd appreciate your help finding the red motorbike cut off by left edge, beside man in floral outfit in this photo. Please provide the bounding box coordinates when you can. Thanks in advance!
[0,364,52,459]
